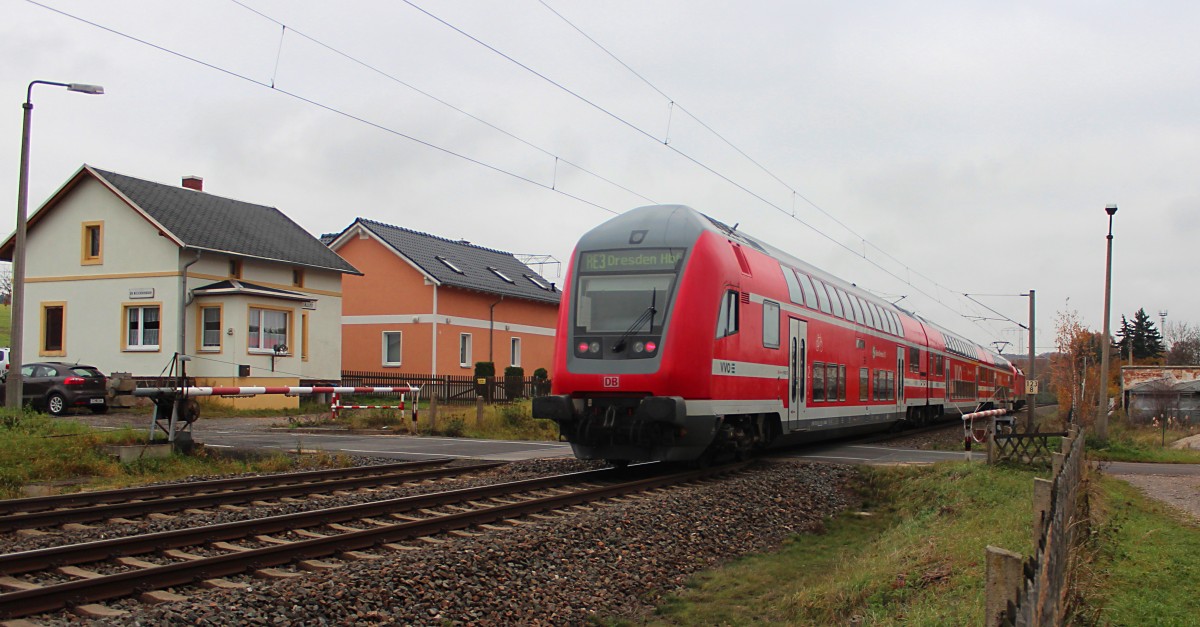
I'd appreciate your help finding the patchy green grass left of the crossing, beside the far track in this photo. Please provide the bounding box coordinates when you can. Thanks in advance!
[0,408,349,498]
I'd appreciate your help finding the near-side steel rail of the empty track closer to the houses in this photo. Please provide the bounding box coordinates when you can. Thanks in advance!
[0,461,504,531]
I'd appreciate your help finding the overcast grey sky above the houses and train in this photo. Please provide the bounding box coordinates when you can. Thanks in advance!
[0,0,1200,352]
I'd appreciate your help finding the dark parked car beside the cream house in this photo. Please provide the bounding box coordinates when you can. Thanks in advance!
[0,362,108,416]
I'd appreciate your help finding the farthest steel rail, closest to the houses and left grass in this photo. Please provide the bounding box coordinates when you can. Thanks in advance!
[0,458,451,514]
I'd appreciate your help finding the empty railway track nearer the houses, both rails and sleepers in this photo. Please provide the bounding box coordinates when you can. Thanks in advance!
[0,459,502,532]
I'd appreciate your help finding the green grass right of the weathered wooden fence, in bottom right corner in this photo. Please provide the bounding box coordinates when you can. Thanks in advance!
[1076,477,1200,626]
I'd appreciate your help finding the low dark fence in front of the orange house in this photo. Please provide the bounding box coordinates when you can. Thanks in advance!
[333,370,550,404]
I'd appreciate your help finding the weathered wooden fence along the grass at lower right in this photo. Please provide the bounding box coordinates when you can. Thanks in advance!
[986,422,1086,626]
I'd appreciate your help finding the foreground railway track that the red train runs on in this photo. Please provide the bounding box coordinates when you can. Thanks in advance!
[0,462,751,619]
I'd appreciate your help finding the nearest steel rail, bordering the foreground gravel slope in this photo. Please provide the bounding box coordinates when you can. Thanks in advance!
[0,461,752,617]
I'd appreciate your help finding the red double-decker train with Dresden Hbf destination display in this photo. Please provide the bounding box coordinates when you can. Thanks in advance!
[533,205,1025,464]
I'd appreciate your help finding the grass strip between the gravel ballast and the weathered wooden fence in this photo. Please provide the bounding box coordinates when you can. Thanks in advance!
[649,462,1037,625]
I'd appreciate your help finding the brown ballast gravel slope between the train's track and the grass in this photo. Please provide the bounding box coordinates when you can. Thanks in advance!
[28,460,853,626]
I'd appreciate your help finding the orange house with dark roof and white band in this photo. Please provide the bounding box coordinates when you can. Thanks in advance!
[322,217,560,376]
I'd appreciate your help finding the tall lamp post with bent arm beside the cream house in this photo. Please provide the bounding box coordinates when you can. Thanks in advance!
[5,80,104,408]
